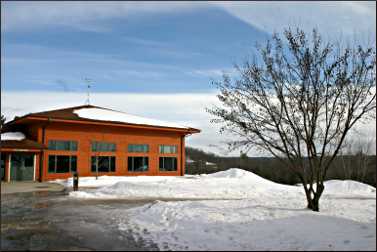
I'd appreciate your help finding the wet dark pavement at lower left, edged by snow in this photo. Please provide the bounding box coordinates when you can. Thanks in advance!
[1,191,158,251]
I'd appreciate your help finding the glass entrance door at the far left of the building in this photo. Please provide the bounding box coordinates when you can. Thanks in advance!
[10,153,34,181]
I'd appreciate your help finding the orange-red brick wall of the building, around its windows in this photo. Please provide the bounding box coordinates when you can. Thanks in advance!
[38,123,185,180]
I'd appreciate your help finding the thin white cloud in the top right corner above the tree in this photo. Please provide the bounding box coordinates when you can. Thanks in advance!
[216,1,376,39]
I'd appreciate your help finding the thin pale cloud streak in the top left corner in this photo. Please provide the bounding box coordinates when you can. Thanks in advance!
[1,1,205,32]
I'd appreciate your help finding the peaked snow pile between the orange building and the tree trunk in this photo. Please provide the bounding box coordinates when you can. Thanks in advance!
[70,169,297,199]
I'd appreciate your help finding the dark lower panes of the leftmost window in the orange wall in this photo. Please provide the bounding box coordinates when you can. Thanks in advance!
[48,155,77,173]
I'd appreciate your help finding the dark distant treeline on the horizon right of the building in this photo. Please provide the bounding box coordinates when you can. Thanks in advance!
[186,147,376,187]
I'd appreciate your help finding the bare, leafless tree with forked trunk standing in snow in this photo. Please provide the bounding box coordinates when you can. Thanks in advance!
[208,29,376,211]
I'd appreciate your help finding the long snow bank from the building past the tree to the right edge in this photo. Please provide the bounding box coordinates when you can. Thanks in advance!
[66,168,375,201]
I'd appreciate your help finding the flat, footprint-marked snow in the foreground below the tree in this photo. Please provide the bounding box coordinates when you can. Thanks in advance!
[119,202,376,251]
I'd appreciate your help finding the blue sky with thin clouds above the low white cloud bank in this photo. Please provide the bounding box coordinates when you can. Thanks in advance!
[1,2,376,93]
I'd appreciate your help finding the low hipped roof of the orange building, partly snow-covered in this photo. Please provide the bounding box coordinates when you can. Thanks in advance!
[5,105,200,133]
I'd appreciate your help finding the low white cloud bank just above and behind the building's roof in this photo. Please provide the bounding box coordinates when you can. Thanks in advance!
[1,90,376,156]
